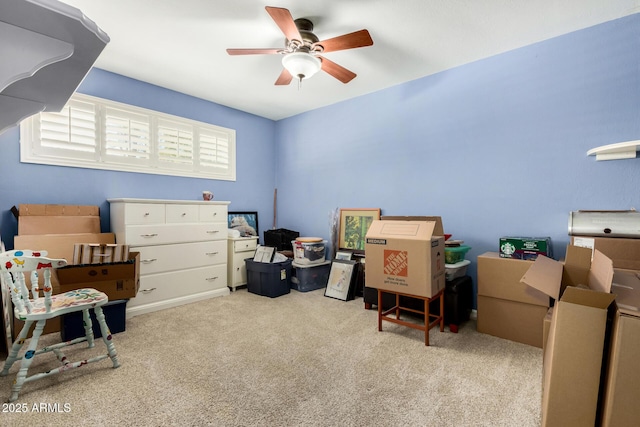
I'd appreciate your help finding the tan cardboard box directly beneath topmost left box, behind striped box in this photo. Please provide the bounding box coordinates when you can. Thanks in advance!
[13,233,116,262]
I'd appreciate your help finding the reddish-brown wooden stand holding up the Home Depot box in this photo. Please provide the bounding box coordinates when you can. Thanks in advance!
[378,289,444,345]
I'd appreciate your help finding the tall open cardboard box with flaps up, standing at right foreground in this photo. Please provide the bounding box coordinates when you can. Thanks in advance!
[522,245,615,426]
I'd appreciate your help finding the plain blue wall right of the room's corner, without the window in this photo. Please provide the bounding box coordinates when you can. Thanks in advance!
[276,14,640,298]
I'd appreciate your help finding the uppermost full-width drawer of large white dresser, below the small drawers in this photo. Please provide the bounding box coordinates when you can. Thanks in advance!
[125,223,227,246]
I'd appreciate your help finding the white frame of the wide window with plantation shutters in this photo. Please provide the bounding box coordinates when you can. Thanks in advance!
[20,93,236,181]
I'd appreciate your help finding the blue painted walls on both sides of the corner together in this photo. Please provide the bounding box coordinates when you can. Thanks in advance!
[0,14,640,306]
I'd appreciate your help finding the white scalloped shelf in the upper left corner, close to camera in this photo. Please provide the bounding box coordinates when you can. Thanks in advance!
[0,0,109,133]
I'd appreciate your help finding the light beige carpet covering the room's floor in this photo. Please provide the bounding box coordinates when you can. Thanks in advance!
[0,289,542,427]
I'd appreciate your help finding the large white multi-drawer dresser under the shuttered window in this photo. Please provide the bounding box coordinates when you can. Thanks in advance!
[108,199,229,316]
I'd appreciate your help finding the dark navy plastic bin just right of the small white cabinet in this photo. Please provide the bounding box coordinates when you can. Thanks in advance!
[244,259,291,298]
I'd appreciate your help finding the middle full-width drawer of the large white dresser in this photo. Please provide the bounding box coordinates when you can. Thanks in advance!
[135,240,227,275]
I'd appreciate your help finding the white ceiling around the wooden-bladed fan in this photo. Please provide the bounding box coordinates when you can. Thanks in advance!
[63,0,640,120]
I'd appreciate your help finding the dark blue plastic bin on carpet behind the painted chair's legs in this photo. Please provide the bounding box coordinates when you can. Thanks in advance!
[60,299,129,341]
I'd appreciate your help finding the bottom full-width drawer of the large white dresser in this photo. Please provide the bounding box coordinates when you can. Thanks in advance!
[128,265,227,307]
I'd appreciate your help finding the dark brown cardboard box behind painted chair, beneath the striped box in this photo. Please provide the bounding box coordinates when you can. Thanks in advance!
[57,252,140,300]
